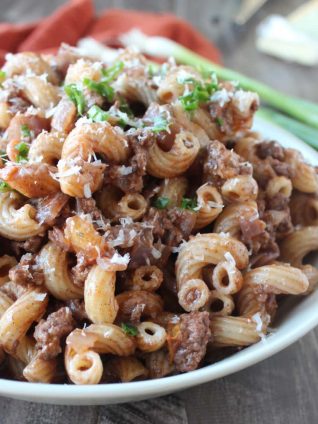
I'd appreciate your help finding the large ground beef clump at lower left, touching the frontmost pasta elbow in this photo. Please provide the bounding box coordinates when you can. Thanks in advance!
[34,307,75,360]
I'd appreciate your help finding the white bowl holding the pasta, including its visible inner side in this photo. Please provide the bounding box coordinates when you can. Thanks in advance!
[0,118,318,405]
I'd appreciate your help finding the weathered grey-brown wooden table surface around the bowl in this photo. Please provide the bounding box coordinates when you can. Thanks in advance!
[0,0,318,424]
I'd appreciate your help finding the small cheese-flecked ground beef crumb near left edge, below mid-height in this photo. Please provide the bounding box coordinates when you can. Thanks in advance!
[9,253,44,286]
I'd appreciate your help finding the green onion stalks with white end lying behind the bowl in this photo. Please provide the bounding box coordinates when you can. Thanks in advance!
[121,29,318,149]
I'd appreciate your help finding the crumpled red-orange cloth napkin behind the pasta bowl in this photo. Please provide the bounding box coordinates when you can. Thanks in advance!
[0,0,220,63]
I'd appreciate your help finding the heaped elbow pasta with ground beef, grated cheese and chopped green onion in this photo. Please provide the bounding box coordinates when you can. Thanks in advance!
[0,46,318,384]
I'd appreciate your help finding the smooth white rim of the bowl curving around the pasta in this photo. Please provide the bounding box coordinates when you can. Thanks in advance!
[0,117,318,404]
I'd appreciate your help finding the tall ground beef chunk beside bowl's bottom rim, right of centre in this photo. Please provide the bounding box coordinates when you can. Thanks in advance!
[174,312,211,372]
